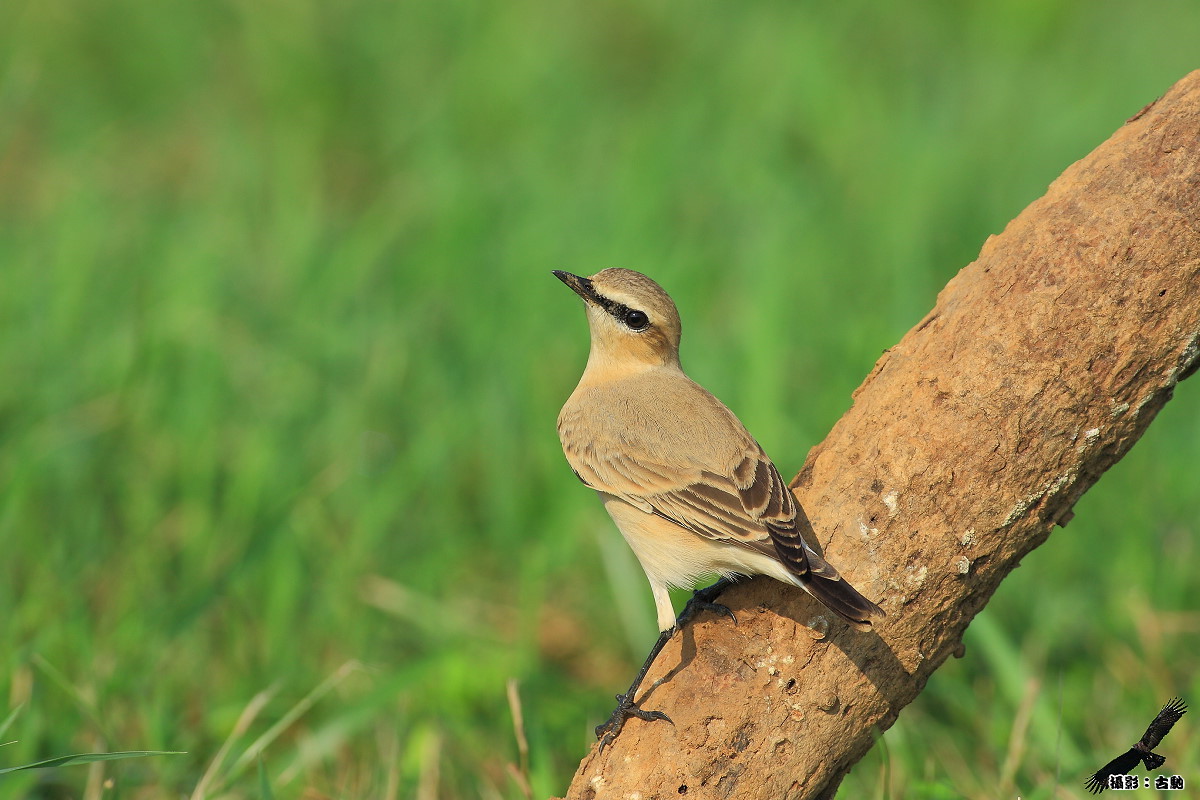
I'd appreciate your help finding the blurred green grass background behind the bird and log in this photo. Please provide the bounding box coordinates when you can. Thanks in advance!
[0,0,1200,800]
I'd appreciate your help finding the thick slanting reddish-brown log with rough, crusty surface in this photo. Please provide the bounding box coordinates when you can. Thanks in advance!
[566,71,1200,800]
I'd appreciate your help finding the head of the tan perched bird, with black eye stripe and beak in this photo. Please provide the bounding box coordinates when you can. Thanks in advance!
[554,267,680,371]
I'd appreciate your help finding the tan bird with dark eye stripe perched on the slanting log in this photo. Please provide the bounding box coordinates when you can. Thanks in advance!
[553,267,884,750]
